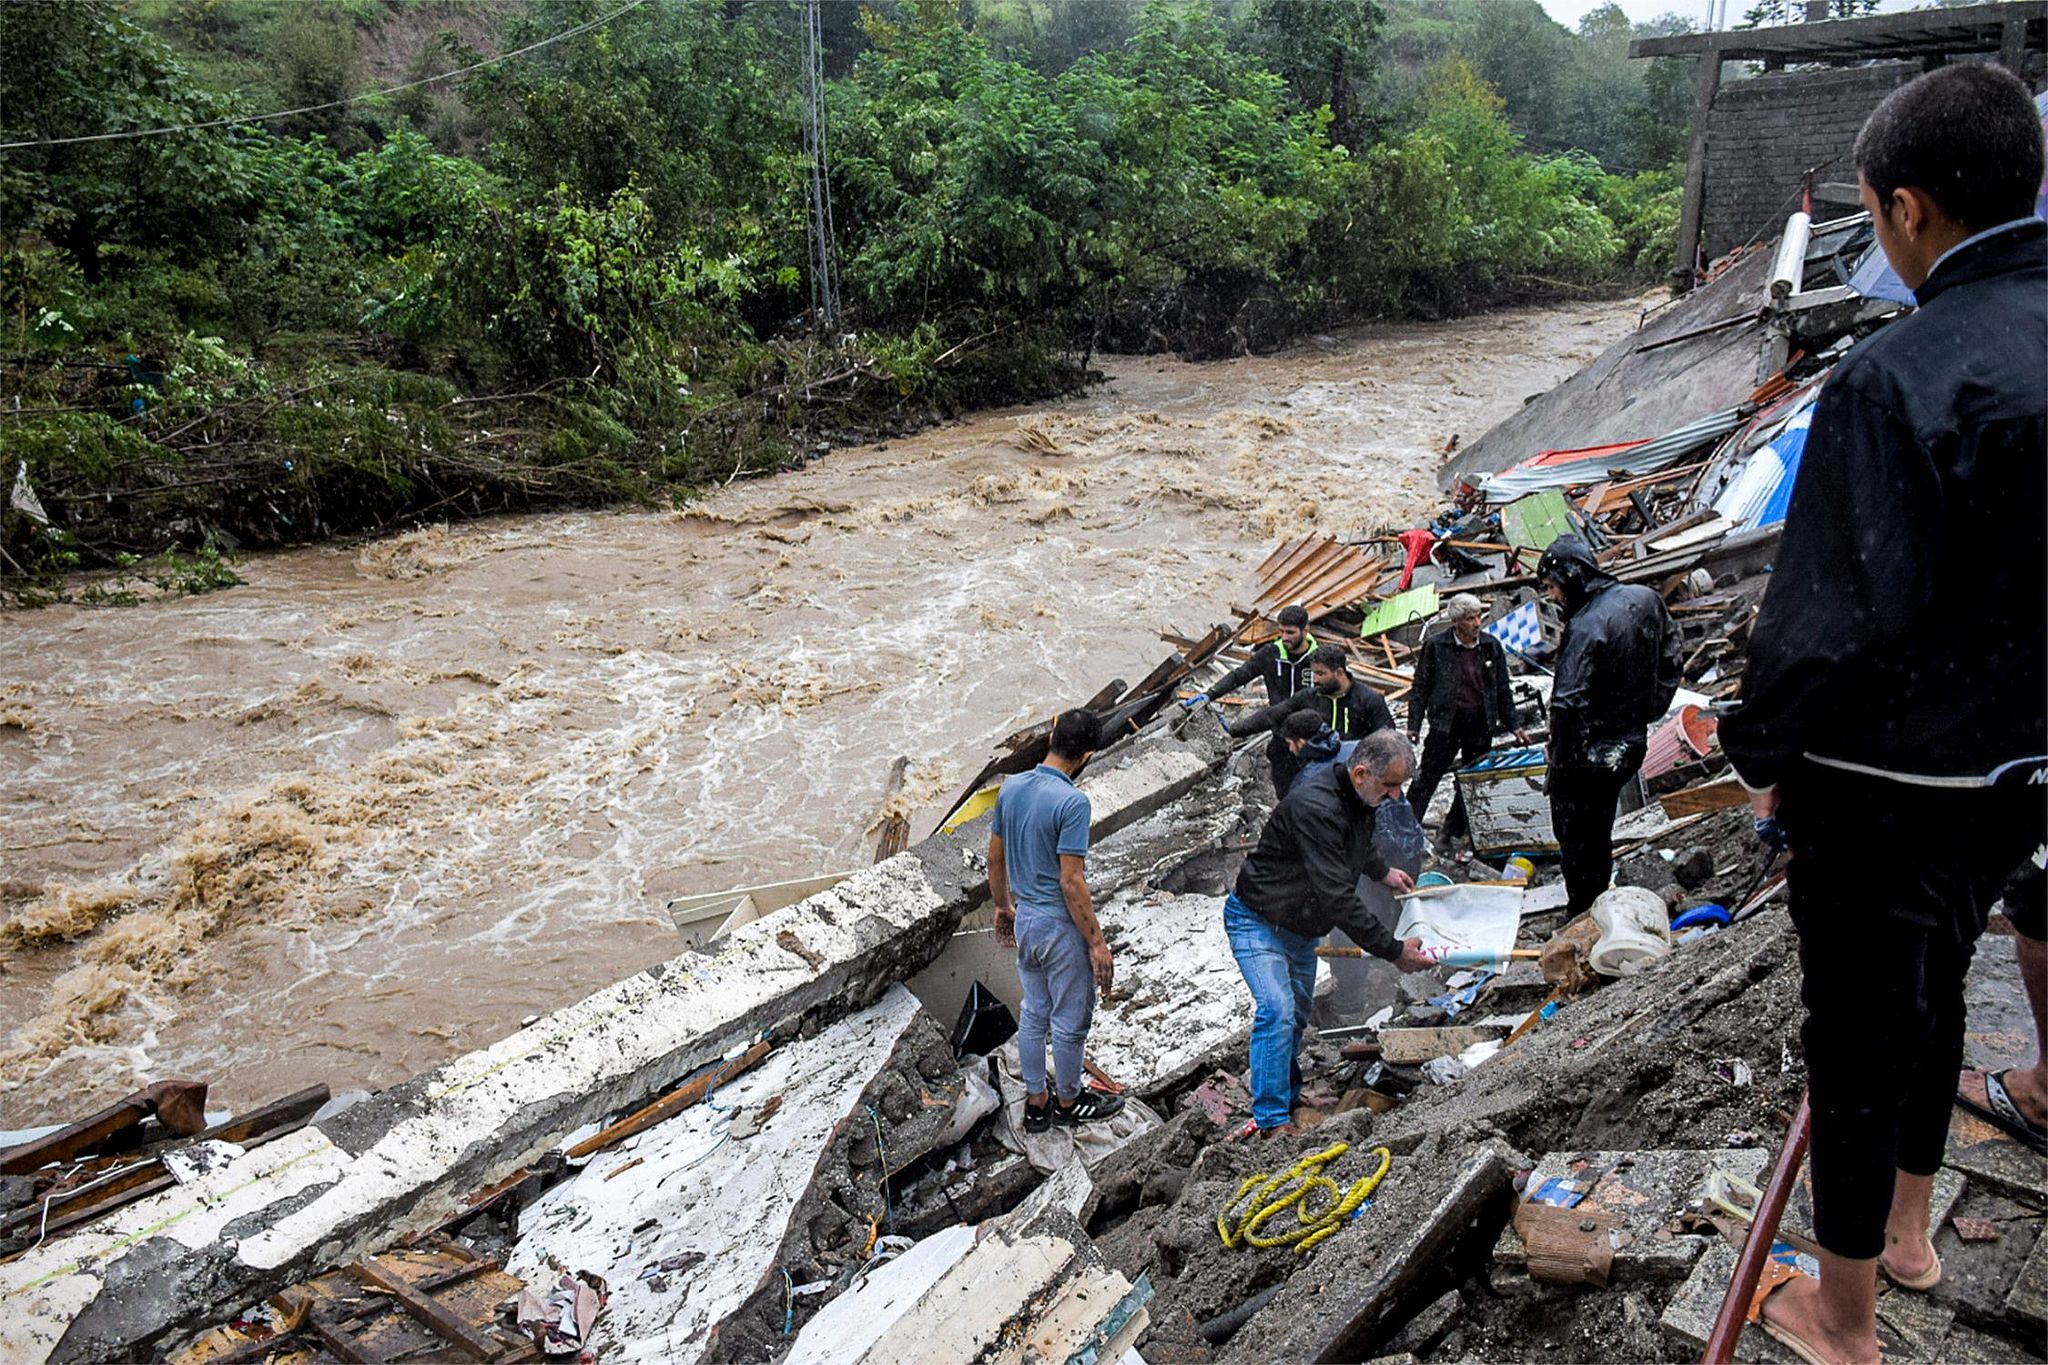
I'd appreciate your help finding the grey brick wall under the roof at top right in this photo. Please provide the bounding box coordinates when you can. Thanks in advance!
[1700,61,1921,260]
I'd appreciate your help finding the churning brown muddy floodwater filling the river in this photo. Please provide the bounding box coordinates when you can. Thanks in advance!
[0,301,1649,1128]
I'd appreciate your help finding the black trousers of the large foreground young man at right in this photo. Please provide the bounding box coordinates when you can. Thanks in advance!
[1778,763,2044,1261]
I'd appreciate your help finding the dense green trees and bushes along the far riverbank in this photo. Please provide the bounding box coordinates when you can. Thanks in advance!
[0,0,1690,593]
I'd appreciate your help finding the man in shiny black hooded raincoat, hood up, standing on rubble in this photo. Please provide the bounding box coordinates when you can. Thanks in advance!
[1536,534,1683,915]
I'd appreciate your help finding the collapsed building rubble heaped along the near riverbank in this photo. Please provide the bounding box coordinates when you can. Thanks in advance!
[0,179,2048,1363]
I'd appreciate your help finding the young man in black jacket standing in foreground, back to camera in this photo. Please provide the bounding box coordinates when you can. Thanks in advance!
[1720,63,2048,1361]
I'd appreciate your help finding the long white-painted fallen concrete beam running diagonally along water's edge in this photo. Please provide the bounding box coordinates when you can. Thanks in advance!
[0,731,1227,1361]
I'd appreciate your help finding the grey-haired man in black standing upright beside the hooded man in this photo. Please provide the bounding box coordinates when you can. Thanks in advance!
[1407,593,1528,849]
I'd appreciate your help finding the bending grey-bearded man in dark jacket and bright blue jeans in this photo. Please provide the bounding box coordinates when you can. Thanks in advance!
[1223,729,1436,1138]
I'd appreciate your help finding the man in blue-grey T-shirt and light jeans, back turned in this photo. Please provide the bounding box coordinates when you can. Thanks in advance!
[989,710,1124,1134]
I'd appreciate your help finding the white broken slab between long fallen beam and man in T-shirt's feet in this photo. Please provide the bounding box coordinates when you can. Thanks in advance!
[506,986,930,1361]
